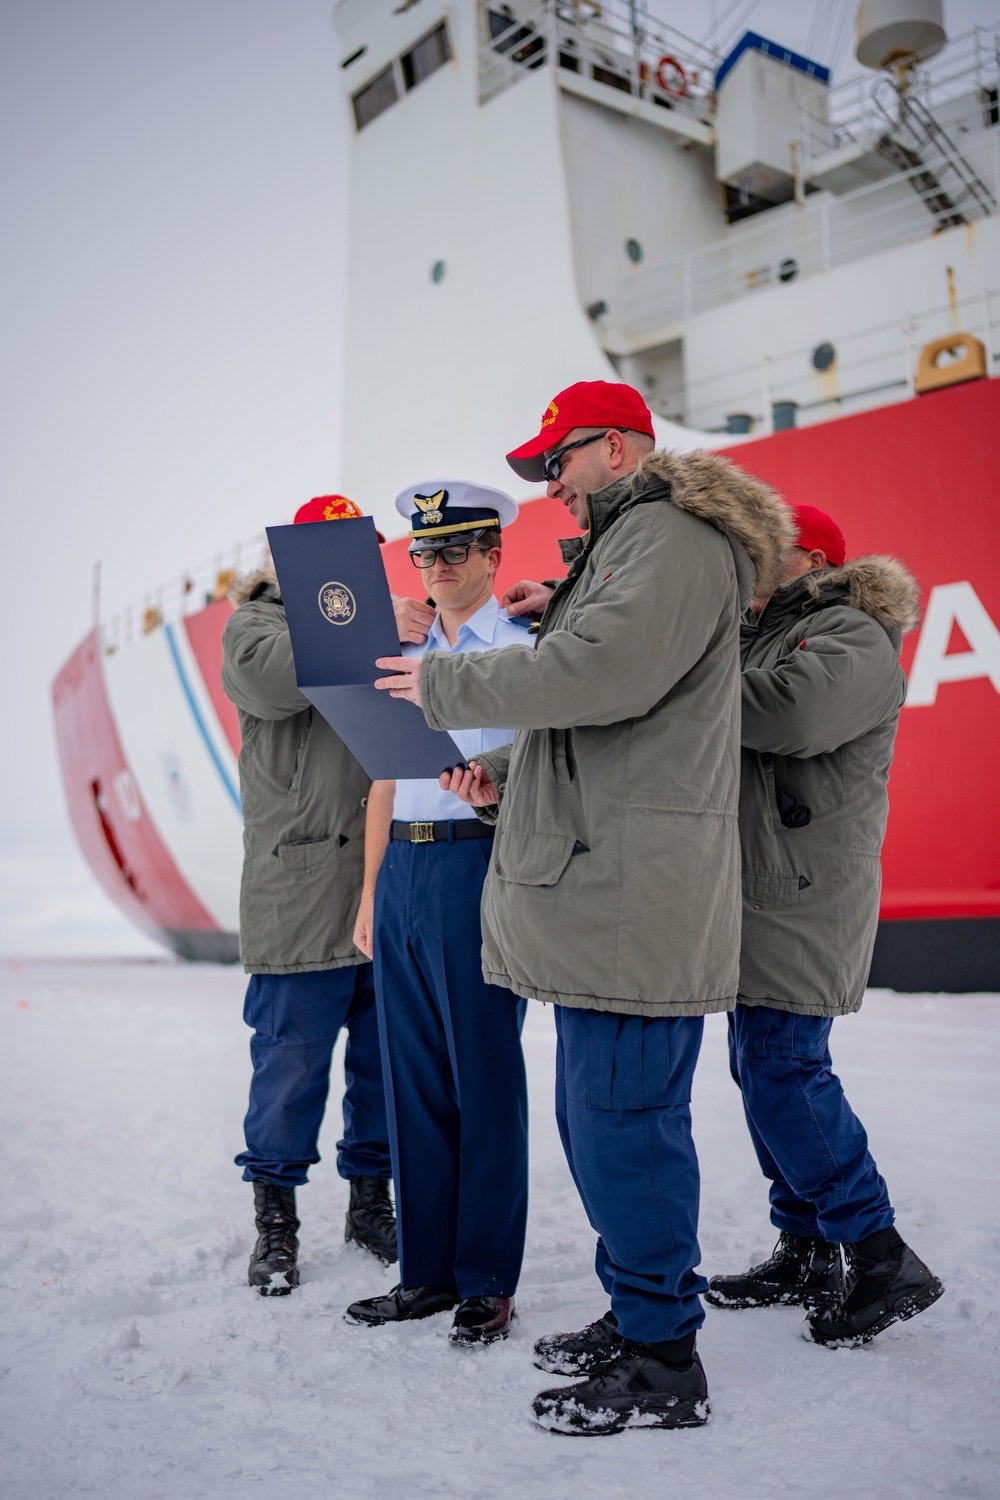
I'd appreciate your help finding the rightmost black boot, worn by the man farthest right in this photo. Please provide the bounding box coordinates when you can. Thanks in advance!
[805,1229,945,1349]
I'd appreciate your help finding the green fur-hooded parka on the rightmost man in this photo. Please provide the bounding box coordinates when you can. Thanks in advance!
[739,557,918,1016]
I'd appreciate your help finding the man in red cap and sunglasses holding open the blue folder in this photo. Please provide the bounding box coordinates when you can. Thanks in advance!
[371,381,792,1434]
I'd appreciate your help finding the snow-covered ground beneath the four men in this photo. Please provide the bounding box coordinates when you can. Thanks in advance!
[0,960,1000,1500]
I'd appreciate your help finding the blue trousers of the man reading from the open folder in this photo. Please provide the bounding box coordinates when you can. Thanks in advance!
[555,1005,708,1343]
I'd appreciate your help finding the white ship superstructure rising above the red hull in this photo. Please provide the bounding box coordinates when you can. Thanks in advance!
[334,0,1000,519]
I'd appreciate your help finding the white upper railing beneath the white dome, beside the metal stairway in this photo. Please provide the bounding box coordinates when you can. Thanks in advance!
[798,26,1000,169]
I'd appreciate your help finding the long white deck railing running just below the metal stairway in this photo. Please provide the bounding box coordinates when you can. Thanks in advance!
[615,129,1000,343]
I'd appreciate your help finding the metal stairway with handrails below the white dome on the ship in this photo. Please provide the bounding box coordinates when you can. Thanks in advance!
[871,78,997,230]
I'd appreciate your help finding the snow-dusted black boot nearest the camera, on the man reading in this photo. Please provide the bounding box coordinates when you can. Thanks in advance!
[532,1340,711,1437]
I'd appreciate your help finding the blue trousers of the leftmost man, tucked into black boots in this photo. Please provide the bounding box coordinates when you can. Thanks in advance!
[235,963,391,1188]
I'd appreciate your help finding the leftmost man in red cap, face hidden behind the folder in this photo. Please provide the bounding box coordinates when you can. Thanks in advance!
[222,495,396,1296]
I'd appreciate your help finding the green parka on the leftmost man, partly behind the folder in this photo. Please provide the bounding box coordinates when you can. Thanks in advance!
[222,567,370,974]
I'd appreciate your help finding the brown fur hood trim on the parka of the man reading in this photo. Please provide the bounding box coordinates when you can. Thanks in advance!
[637,450,796,597]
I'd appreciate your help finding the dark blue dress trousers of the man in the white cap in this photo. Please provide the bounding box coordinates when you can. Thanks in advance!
[375,839,528,1298]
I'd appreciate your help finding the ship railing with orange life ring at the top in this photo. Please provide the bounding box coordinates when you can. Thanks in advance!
[478,0,718,120]
